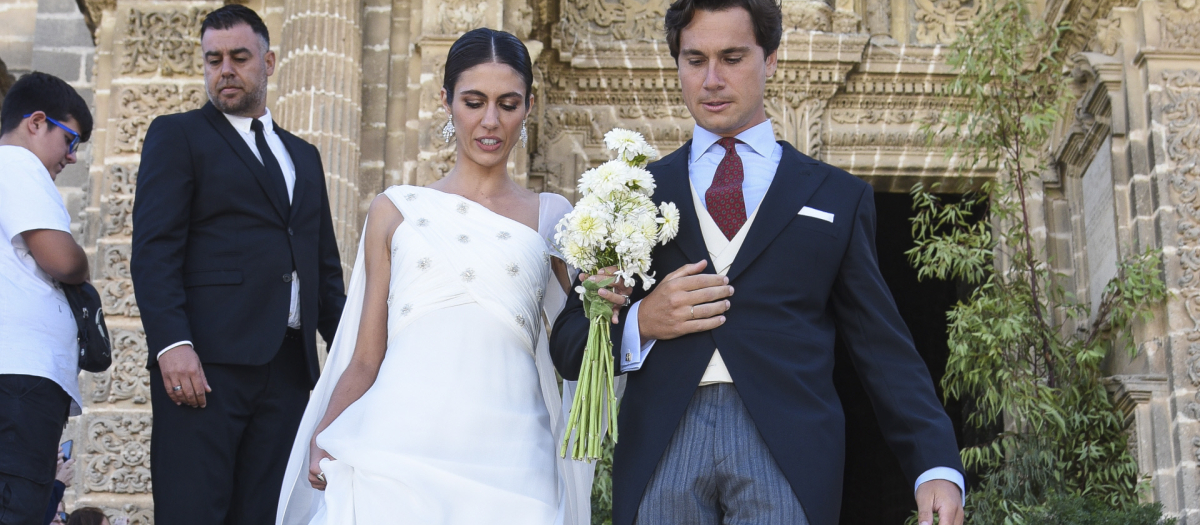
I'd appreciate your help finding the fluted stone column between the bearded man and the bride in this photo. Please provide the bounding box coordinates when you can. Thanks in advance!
[271,0,370,270]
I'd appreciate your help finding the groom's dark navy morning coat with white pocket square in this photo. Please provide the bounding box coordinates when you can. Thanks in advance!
[550,141,962,525]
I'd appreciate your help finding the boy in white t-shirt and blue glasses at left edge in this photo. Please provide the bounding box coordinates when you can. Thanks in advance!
[0,73,92,525]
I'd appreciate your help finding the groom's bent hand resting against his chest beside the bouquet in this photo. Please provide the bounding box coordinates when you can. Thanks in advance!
[637,260,733,344]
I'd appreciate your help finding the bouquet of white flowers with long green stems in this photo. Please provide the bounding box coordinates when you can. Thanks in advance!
[554,128,679,460]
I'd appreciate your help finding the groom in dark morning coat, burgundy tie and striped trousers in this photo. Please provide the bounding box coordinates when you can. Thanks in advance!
[551,0,962,525]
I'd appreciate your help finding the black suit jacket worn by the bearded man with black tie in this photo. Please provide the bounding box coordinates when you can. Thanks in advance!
[130,103,346,384]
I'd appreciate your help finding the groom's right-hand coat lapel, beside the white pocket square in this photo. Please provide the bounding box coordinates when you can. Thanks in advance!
[727,141,826,282]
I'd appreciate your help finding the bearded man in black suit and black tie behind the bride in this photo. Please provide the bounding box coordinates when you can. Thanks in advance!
[131,5,346,525]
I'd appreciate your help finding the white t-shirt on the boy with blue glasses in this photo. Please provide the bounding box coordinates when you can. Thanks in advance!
[0,146,82,416]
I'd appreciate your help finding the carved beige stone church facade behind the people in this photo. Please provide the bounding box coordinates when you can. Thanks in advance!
[0,0,1200,517]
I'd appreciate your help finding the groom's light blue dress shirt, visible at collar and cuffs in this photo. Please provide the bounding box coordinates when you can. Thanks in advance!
[620,119,967,502]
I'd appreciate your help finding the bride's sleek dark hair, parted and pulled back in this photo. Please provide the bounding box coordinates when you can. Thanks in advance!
[442,28,533,105]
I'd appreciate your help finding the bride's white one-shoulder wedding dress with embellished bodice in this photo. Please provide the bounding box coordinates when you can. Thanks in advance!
[276,186,593,525]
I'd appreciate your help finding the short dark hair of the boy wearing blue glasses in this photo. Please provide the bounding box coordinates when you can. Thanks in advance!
[0,71,92,143]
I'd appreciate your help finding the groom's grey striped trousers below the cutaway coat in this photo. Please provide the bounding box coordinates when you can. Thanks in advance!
[636,384,809,525]
